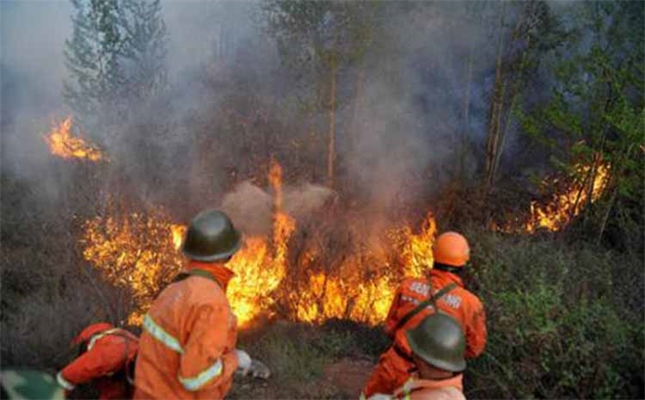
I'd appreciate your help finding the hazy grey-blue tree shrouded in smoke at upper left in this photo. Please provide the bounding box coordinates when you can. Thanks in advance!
[64,0,167,130]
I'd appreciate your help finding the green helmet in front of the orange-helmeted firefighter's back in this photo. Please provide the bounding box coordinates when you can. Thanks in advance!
[406,312,466,372]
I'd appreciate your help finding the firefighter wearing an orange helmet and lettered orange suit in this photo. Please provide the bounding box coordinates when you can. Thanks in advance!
[363,232,486,397]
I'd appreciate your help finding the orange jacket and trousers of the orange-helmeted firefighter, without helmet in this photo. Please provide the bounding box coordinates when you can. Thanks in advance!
[363,269,487,397]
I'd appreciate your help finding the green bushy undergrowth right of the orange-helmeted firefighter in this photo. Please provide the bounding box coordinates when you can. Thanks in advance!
[466,228,645,398]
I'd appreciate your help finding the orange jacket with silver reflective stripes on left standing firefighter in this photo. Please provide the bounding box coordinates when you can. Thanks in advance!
[134,261,238,399]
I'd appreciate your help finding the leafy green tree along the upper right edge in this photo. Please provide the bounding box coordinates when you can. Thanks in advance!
[517,2,645,248]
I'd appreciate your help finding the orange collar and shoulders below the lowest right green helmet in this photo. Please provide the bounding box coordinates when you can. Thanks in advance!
[394,374,466,400]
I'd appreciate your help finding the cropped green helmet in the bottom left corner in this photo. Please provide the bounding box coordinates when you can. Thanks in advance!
[0,369,65,400]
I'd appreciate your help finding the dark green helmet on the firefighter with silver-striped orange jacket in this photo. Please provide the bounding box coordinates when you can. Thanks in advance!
[182,210,242,262]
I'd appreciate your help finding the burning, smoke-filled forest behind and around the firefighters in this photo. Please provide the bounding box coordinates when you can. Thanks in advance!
[0,0,645,399]
